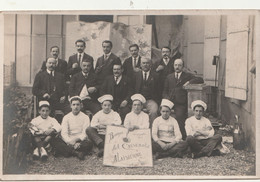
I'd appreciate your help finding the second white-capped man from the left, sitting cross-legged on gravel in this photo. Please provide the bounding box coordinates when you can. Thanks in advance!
[52,96,93,160]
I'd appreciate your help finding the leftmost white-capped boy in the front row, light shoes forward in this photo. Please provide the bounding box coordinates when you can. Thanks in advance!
[29,101,61,160]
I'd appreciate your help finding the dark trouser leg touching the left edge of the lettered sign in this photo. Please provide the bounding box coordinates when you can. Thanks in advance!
[86,127,105,149]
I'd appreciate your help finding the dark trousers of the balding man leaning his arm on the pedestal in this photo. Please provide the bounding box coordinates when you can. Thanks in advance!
[173,104,188,140]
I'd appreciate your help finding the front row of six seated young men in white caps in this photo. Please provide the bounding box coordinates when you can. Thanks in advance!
[29,94,222,160]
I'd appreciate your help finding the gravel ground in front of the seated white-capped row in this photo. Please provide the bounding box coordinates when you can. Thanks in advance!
[27,144,256,176]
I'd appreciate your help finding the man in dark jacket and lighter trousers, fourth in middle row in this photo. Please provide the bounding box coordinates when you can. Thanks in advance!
[134,57,160,126]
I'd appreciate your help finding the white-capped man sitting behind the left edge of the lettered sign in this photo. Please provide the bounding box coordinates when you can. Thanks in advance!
[86,95,122,157]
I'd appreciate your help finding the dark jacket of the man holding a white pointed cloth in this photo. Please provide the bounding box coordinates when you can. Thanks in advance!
[69,72,99,99]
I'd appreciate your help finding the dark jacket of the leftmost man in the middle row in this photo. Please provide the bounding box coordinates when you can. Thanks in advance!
[32,70,67,101]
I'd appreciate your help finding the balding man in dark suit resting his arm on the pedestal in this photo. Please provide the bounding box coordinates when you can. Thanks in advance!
[163,59,204,139]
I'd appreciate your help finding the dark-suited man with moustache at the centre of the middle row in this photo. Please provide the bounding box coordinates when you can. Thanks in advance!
[100,64,133,121]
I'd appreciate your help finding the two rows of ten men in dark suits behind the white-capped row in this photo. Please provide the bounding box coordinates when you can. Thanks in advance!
[32,40,203,139]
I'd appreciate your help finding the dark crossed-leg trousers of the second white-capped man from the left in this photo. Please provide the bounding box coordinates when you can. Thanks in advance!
[51,137,93,157]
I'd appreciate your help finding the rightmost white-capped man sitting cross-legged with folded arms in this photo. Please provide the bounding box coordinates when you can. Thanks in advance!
[185,100,222,158]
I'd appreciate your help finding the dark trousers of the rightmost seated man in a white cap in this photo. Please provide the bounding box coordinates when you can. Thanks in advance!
[186,134,222,156]
